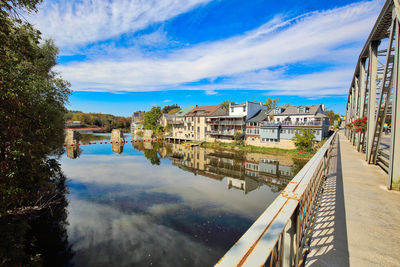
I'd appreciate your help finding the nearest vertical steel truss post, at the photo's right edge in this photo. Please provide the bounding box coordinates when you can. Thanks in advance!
[387,18,400,189]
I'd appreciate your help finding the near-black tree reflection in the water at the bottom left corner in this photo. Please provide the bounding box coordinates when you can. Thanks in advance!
[0,161,73,266]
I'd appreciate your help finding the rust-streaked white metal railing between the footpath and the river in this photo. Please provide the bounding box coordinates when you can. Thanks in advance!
[216,133,337,266]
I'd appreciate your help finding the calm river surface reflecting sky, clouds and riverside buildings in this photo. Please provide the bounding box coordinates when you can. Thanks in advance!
[62,135,304,266]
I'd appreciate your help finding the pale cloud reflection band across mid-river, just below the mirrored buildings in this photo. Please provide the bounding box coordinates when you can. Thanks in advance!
[63,155,277,218]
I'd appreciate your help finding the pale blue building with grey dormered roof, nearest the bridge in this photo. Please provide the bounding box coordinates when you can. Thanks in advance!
[246,105,329,148]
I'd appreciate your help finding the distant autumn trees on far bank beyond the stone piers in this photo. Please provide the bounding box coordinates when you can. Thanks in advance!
[65,111,131,132]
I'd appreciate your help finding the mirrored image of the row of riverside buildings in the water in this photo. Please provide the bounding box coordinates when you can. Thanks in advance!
[163,144,295,194]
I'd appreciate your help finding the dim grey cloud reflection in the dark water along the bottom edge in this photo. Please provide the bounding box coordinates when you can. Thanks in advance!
[68,199,220,266]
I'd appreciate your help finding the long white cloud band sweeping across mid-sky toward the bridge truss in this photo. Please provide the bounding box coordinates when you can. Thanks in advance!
[45,0,382,95]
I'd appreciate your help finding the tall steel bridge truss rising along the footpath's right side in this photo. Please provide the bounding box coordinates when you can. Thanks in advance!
[346,0,400,189]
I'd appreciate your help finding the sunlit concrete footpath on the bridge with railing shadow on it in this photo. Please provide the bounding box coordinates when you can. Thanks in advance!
[306,133,400,266]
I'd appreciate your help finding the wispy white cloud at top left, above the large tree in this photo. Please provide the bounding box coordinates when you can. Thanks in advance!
[29,0,210,48]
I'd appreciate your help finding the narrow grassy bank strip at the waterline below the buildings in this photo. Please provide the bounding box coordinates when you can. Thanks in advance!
[201,142,313,159]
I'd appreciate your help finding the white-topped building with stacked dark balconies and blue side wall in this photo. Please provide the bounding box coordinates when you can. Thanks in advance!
[207,101,267,142]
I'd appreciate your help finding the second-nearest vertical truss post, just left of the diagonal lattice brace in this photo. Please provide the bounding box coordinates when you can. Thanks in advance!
[366,42,379,161]
